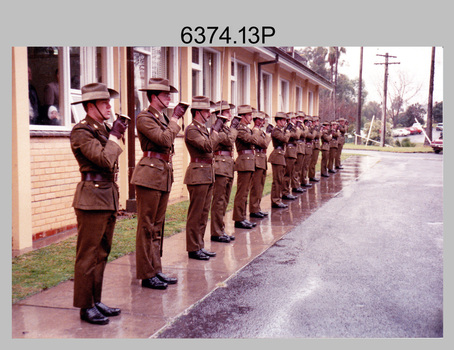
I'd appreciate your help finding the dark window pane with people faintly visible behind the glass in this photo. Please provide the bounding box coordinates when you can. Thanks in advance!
[27,47,64,125]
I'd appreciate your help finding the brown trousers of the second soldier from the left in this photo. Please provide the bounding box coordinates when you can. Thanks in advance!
[136,186,170,279]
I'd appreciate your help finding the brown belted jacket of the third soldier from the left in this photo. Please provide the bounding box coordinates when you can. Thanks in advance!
[183,120,219,185]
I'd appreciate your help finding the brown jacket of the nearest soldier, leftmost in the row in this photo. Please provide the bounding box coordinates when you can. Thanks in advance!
[70,115,123,211]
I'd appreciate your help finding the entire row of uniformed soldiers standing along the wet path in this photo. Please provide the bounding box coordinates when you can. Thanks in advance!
[70,78,346,325]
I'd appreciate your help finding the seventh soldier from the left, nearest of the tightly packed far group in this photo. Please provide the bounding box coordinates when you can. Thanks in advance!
[268,112,290,208]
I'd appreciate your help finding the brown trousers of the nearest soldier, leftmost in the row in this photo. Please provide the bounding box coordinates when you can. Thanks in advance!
[73,209,117,309]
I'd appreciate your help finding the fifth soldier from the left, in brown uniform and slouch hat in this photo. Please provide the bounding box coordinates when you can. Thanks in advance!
[232,105,256,229]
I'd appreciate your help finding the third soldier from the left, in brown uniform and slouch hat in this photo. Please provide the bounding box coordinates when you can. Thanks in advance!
[184,96,222,260]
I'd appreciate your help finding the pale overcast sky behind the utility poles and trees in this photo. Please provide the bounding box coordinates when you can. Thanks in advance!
[338,46,443,106]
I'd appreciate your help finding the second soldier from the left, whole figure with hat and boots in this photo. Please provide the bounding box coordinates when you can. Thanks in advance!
[131,78,185,289]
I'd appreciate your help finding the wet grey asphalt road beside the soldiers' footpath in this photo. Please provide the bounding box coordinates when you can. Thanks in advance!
[155,152,443,338]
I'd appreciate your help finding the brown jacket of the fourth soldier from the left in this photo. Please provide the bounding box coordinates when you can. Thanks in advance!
[214,124,238,178]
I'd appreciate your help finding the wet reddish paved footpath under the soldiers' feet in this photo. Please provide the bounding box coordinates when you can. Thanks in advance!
[12,155,378,338]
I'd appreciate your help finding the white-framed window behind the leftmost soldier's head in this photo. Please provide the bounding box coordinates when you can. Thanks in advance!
[27,47,108,131]
